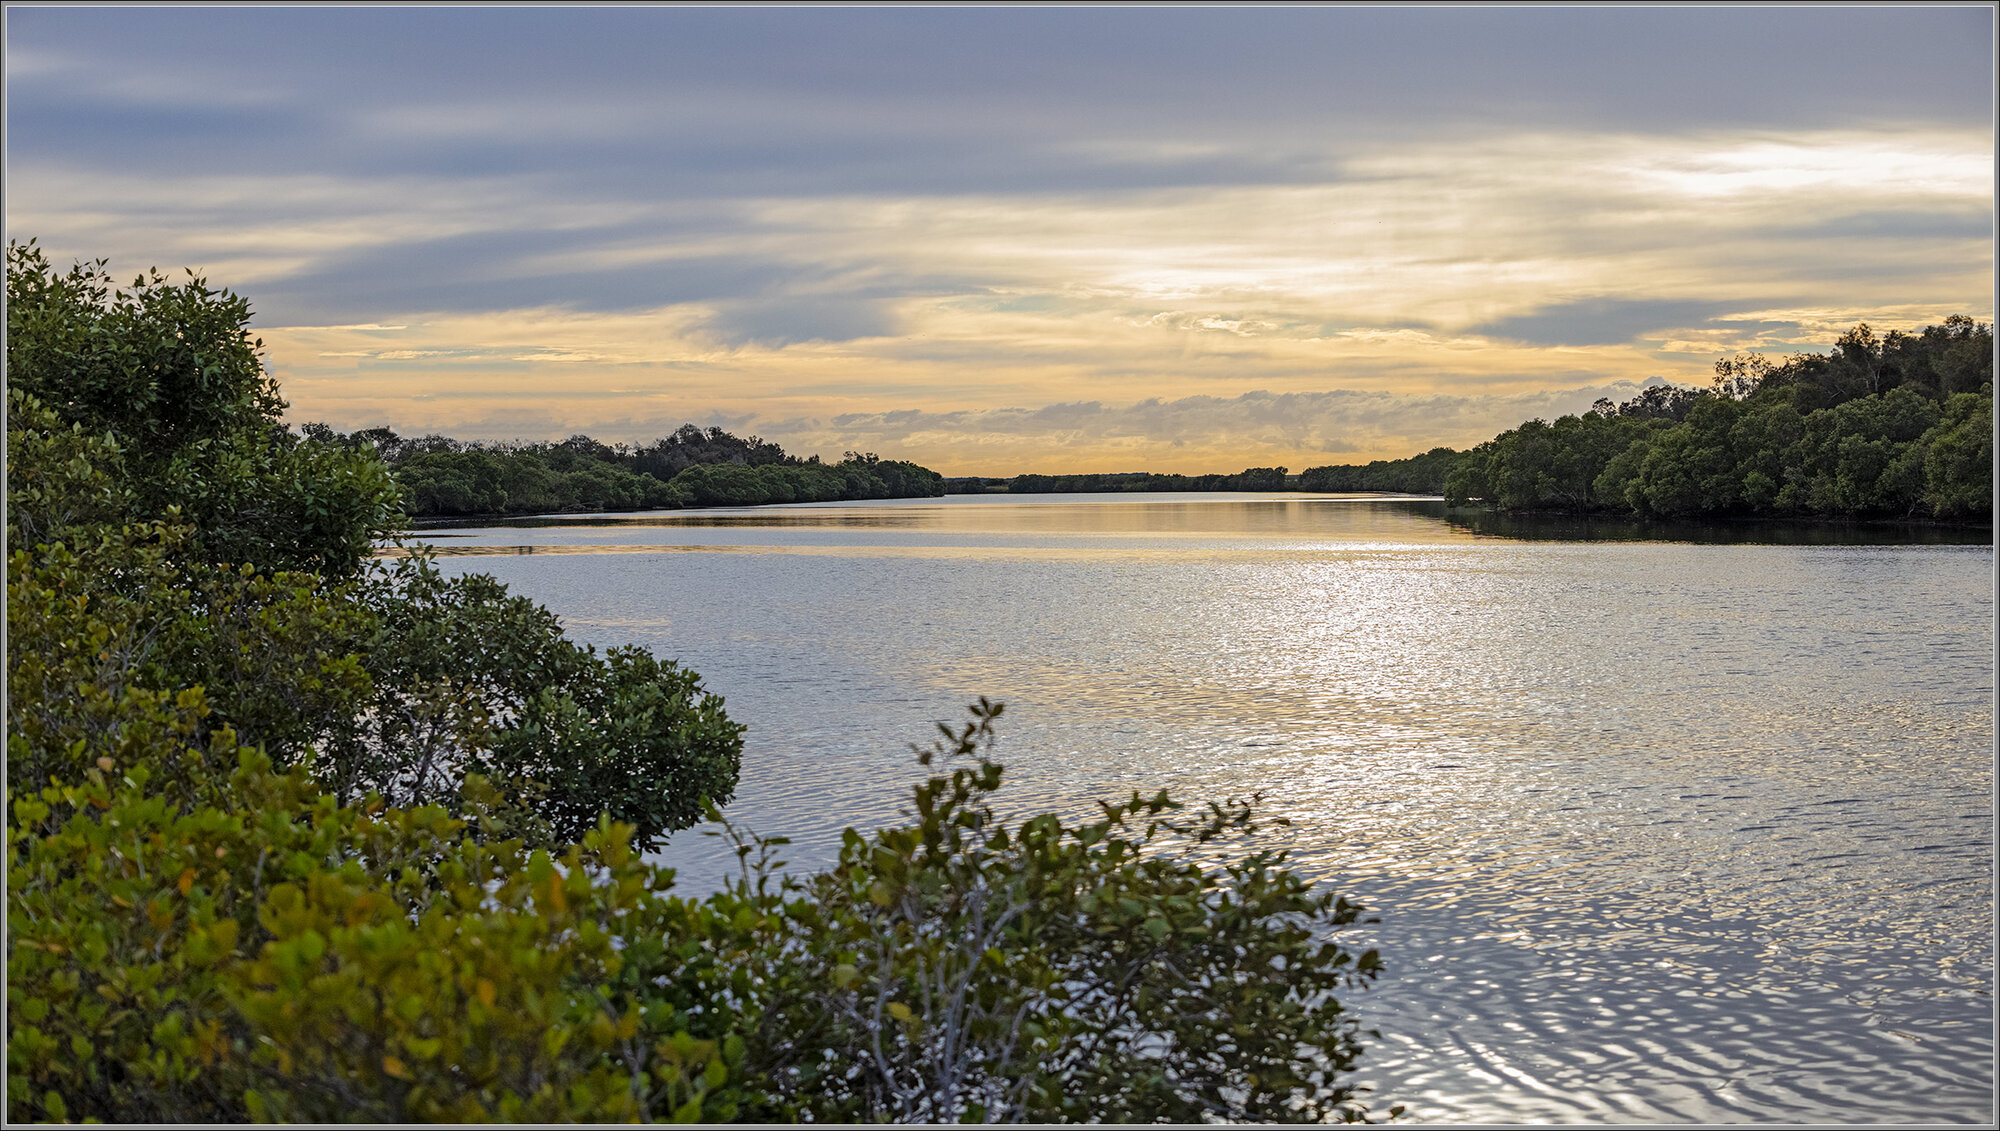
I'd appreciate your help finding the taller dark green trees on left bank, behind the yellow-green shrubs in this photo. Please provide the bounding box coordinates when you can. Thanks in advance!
[6,244,742,847]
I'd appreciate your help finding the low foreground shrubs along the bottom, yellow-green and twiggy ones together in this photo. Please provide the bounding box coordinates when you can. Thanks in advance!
[8,689,1394,1123]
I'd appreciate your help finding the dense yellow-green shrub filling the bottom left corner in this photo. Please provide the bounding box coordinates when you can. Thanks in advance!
[8,737,742,1123]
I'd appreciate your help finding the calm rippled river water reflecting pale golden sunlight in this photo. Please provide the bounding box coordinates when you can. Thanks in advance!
[398,496,1994,1123]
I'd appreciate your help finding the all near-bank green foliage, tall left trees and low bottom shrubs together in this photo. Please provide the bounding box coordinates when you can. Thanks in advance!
[6,242,1402,1123]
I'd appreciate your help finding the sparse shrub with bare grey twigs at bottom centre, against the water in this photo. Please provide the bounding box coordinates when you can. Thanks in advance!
[718,699,1400,1123]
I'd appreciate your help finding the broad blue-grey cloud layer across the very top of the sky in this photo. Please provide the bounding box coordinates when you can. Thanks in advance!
[8,8,1992,192]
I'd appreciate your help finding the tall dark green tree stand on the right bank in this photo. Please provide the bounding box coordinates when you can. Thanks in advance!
[1442,316,1994,522]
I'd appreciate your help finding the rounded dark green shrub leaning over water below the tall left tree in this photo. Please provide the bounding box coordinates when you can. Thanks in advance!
[332,556,742,847]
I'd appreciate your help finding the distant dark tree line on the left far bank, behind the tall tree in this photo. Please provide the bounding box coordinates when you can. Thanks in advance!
[302,424,944,518]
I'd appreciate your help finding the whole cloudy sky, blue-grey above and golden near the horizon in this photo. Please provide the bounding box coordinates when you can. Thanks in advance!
[6,6,1994,476]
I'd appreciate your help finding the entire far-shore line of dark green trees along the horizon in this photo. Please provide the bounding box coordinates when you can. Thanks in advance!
[368,316,1994,526]
